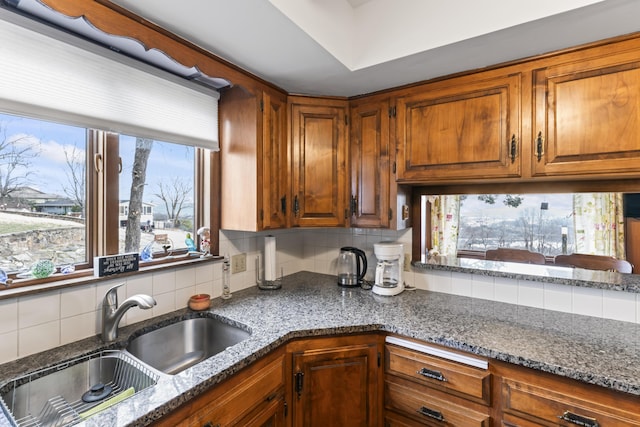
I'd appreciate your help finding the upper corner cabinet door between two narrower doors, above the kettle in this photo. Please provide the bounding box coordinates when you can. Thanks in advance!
[291,99,349,227]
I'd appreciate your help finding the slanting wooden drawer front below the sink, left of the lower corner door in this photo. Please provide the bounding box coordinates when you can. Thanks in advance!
[190,358,284,427]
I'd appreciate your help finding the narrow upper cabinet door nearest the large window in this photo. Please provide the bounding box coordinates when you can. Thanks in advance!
[258,93,289,230]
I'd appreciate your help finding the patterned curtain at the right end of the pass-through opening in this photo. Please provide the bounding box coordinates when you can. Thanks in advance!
[573,193,625,259]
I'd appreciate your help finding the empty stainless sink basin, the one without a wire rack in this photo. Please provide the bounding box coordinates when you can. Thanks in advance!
[127,317,251,375]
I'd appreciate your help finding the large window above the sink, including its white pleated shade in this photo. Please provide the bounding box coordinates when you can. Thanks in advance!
[0,14,219,290]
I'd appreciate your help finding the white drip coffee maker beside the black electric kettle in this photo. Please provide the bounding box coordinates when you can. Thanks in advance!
[371,242,404,296]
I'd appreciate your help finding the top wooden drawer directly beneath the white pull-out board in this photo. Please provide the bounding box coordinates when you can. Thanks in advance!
[386,344,491,405]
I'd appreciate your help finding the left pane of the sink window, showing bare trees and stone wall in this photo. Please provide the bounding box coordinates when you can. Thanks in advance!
[0,114,88,272]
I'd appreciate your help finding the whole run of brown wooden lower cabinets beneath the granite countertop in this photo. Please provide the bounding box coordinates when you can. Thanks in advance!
[154,334,640,427]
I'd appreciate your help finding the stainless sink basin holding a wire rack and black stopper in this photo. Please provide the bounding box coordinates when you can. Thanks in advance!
[0,351,159,426]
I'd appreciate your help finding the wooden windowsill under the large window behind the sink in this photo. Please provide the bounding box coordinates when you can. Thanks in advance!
[0,255,224,300]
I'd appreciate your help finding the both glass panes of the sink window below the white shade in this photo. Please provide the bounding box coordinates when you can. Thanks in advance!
[0,113,209,286]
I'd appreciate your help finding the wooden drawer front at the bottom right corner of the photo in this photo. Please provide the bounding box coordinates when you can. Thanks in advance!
[502,378,640,427]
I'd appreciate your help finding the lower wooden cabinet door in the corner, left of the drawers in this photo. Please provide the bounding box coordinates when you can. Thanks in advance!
[293,344,378,427]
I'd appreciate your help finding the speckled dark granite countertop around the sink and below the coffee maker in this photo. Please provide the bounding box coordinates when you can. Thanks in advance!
[0,272,640,427]
